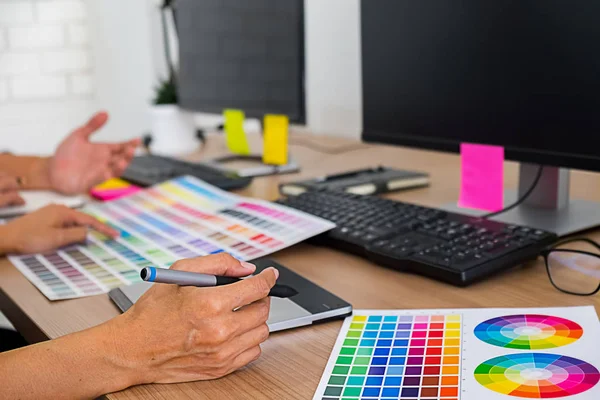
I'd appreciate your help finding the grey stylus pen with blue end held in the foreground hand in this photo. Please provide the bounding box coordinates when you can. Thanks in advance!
[140,267,298,298]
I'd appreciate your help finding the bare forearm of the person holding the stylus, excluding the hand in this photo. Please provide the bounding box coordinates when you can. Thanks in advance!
[0,323,138,400]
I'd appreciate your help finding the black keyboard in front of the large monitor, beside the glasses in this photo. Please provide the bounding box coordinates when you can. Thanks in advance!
[278,192,557,286]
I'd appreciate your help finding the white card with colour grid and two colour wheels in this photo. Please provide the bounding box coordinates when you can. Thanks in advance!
[313,307,600,400]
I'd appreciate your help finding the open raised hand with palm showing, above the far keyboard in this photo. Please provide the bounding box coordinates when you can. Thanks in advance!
[47,112,140,194]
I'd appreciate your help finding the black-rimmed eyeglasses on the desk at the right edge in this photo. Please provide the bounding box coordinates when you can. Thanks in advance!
[541,239,600,296]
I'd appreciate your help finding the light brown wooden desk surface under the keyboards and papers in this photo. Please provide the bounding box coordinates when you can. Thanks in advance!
[0,136,600,400]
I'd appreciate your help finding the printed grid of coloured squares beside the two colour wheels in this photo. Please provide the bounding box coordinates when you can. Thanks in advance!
[314,311,461,400]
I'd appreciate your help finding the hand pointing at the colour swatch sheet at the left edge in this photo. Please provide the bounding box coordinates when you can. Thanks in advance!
[0,205,117,254]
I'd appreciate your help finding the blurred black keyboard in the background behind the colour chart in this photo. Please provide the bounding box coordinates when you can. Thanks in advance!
[122,155,252,190]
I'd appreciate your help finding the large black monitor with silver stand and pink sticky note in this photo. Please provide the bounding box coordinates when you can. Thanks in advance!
[361,0,600,234]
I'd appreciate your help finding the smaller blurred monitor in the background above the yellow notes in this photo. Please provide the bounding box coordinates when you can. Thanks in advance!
[175,0,306,123]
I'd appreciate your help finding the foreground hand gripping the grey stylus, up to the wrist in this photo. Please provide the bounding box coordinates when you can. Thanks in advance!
[108,254,279,383]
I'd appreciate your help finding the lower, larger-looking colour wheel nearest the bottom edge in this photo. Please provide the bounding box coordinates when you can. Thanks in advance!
[475,353,600,399]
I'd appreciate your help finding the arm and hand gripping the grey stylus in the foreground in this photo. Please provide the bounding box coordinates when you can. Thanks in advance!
[0,254,279,400]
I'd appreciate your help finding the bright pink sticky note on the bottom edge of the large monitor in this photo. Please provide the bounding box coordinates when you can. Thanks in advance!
[458,143,504,212]
